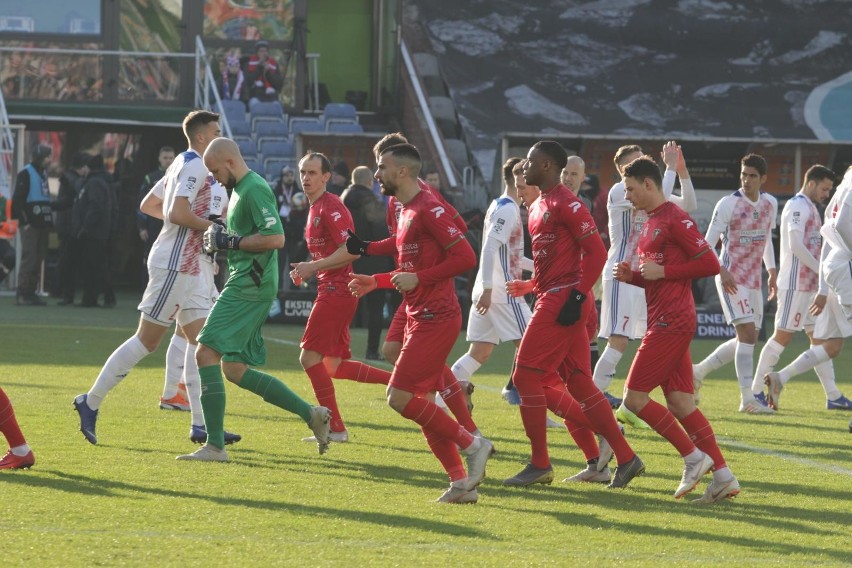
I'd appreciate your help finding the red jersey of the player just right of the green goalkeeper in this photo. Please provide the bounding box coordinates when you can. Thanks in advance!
[305,191,355,296]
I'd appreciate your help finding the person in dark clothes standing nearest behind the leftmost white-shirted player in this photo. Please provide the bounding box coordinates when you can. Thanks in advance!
[72,154,114,308]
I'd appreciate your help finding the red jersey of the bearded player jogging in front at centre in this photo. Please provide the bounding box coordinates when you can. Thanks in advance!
[396,191,464,321]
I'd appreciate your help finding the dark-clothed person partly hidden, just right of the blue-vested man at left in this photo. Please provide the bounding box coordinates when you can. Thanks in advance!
[53,152,91,306]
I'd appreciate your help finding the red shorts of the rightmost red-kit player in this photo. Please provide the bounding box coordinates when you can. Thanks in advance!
[625,332,693,394]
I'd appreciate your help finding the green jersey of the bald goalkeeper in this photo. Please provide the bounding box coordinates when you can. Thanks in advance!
[225,171,284,301]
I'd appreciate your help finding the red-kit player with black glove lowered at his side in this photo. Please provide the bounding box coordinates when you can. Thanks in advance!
[503,140,645,488]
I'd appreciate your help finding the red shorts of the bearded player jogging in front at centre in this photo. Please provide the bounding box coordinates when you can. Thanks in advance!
[388,314,461,395]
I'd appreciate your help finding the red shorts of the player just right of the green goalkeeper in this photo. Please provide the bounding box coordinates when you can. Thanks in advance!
[299,295,358,359]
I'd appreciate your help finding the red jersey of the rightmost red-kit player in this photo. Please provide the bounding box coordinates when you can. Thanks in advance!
[638,201,713,333]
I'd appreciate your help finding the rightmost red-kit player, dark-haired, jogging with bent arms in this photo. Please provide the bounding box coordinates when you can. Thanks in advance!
[613,156,740,503]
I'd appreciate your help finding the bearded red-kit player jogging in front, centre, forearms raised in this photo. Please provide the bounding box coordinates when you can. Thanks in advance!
[349,144,494,503]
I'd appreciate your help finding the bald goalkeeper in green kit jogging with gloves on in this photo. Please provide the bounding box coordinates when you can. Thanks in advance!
[177,138,330,462]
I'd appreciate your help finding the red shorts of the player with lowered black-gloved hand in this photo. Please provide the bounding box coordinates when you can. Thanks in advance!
[518,288,593,380]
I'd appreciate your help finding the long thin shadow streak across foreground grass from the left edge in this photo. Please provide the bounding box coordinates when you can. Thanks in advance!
[0,464,494,540]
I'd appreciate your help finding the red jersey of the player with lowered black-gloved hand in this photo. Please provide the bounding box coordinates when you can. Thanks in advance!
[528,184,599,294]
